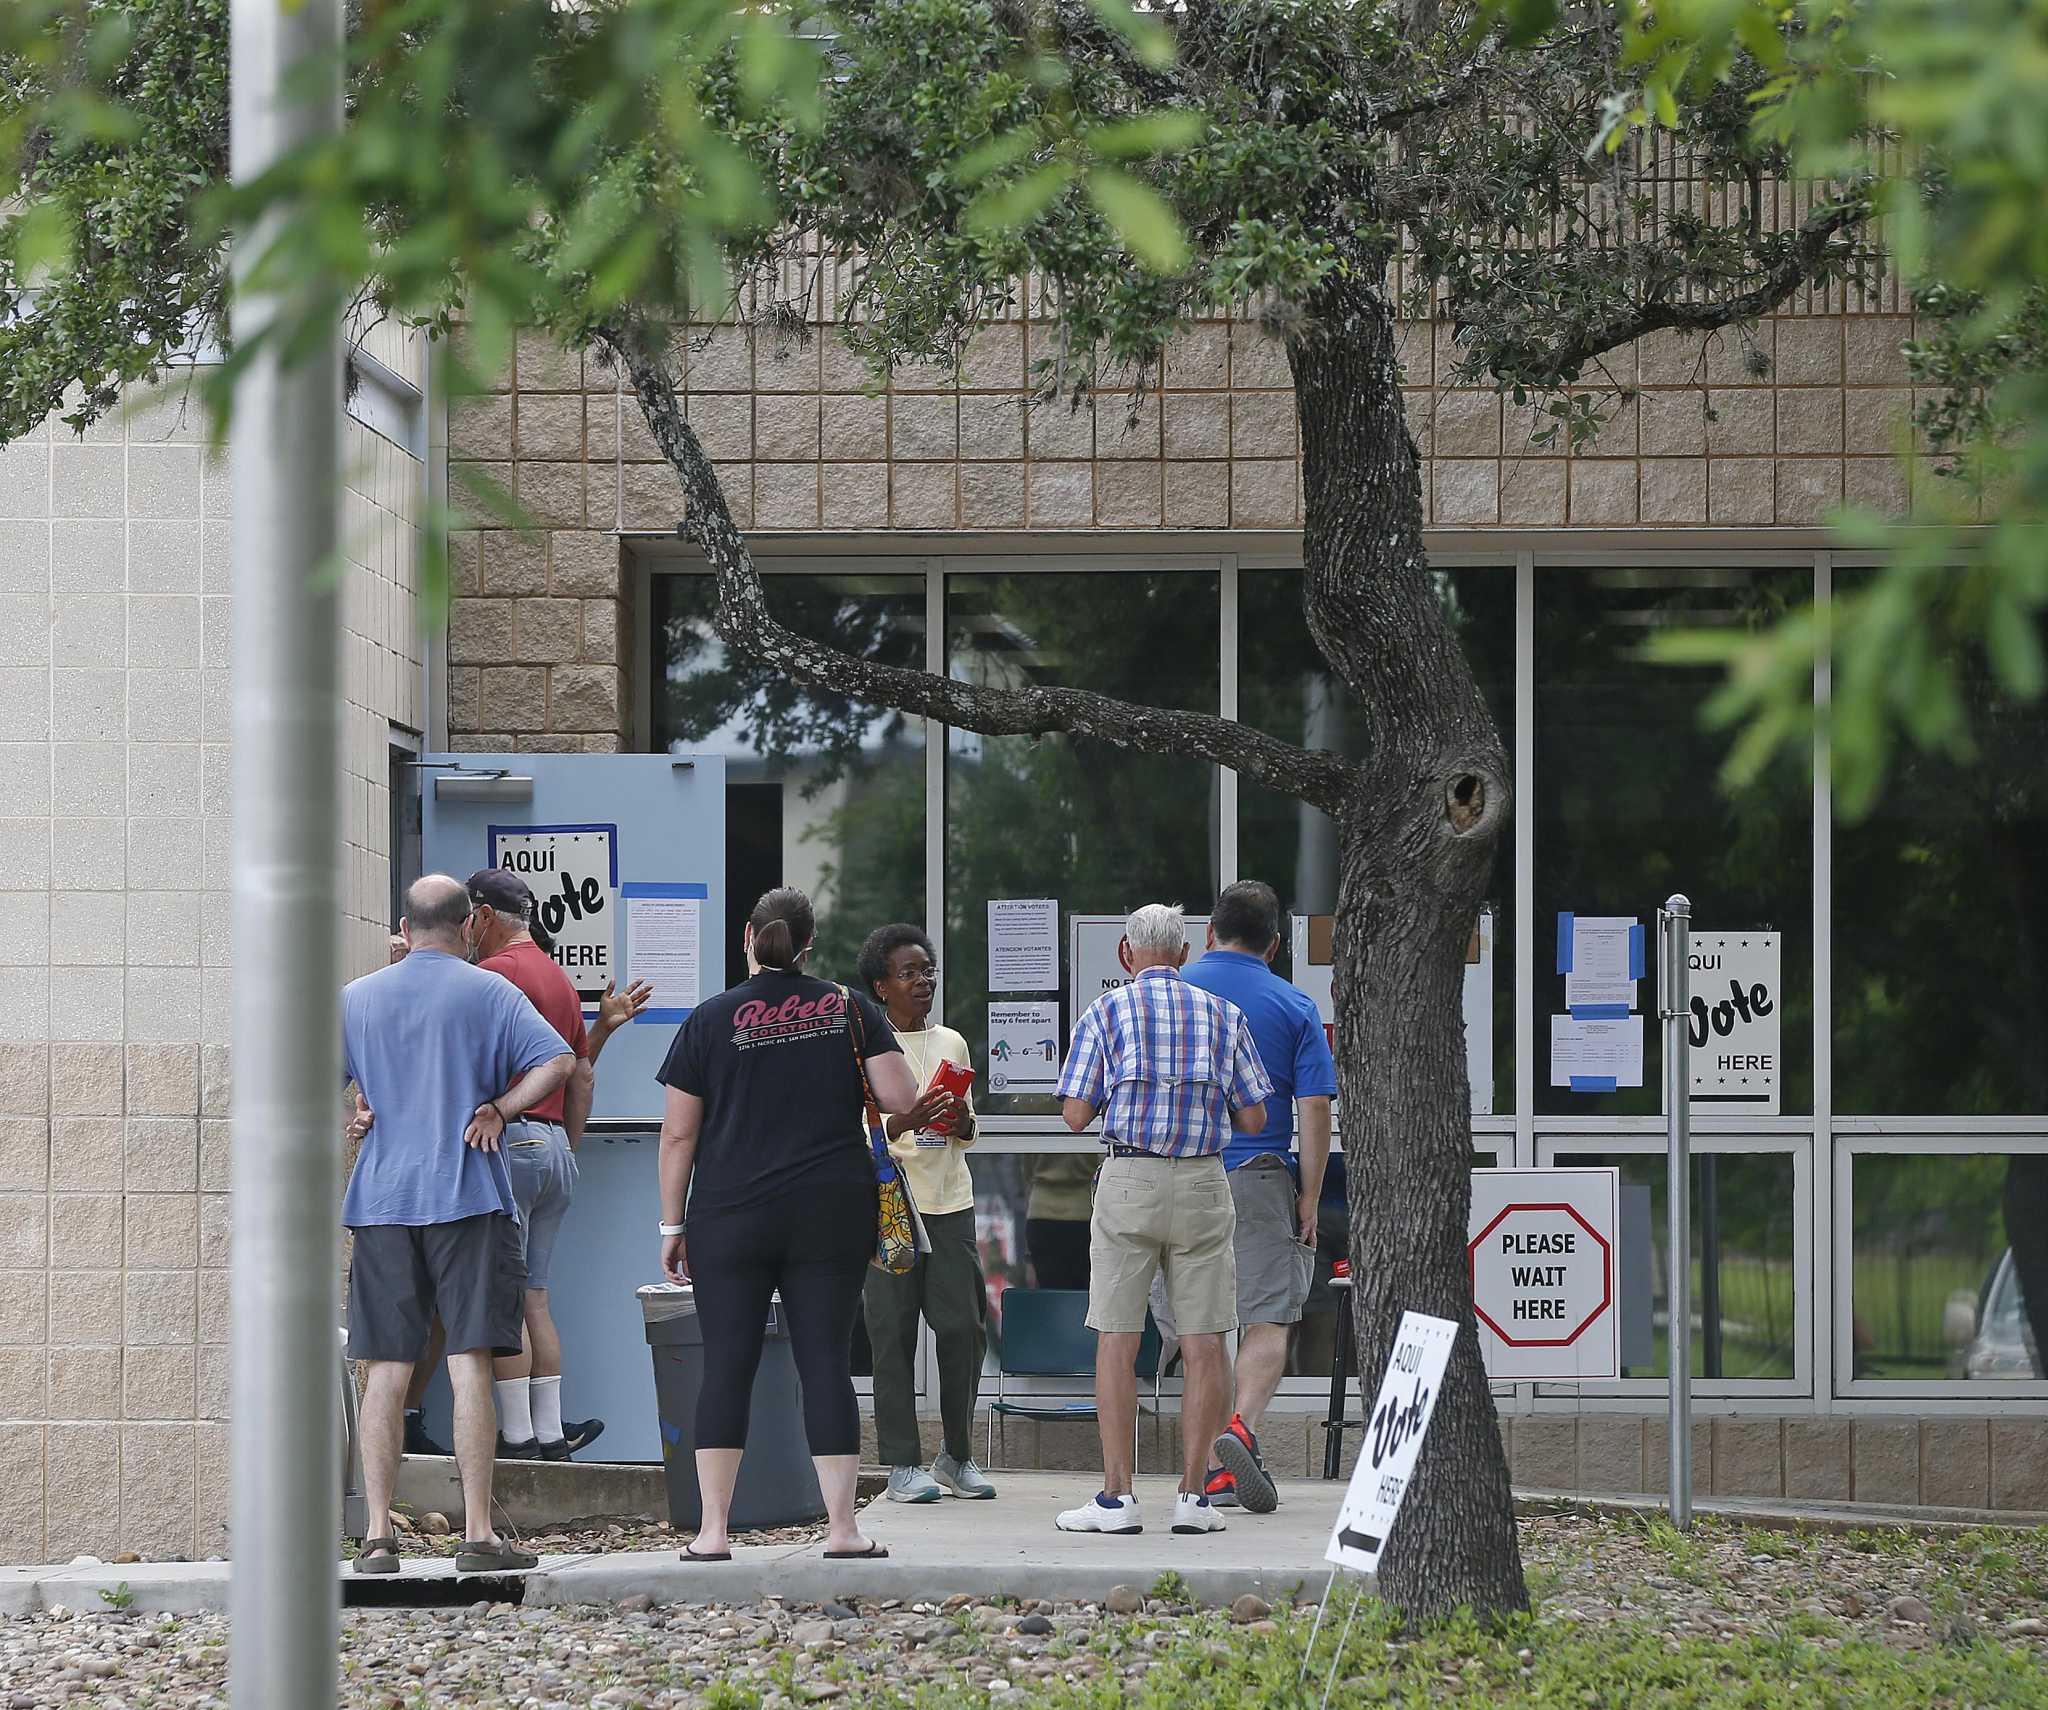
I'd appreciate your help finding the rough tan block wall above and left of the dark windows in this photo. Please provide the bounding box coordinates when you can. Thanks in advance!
[449,313,1913,750]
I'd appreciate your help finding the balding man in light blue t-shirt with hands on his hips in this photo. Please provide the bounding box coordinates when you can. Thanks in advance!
[342,872,575,1573]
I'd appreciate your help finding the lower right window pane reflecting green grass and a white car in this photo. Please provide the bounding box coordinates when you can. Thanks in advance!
[1849,1153,2048,1382]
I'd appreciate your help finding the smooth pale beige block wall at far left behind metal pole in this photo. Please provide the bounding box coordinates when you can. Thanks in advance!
[0,354,420,1561]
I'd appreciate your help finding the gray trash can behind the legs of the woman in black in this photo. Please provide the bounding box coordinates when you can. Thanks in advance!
[639,1282,825,1532]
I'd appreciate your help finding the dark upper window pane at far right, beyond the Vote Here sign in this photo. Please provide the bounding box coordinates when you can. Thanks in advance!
[1835,610,2048,1116]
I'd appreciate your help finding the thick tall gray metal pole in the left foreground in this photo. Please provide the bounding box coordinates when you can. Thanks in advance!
[227,0,342,1710]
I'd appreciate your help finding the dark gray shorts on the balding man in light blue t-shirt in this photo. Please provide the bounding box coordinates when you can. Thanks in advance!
[348,1212,526,1364]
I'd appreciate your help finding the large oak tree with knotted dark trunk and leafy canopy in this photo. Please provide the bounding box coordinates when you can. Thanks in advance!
[0,0,1870,1618]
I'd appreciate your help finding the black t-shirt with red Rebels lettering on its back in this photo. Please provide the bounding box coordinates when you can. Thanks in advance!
[657,969,901,1216]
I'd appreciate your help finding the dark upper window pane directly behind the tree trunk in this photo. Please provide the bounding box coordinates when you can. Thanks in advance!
[1237,567,1516,1114]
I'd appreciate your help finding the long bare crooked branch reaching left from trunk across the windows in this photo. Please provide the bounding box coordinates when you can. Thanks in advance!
[596,328,1362,815]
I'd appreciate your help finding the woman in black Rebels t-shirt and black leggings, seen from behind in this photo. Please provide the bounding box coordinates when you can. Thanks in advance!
[659,889,918,1561]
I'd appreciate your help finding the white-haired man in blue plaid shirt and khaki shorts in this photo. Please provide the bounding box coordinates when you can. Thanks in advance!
[1057,903,1274,1532]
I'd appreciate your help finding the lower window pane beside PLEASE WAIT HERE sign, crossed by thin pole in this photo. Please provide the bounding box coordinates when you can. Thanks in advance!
[1556,1153,1796,1378]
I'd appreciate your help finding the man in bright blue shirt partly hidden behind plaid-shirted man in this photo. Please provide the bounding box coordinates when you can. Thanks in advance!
[1184,879,1337,1513]
